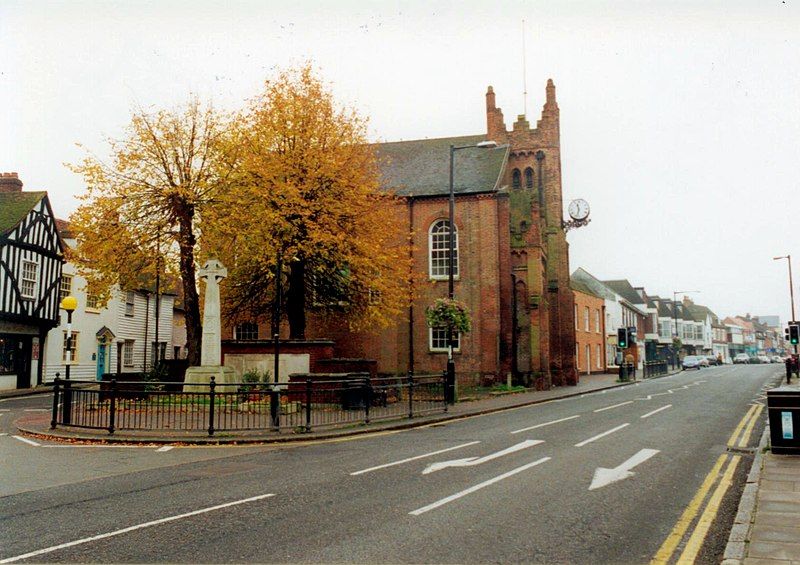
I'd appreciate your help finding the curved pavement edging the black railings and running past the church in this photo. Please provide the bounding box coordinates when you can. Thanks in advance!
[9,373,652,444]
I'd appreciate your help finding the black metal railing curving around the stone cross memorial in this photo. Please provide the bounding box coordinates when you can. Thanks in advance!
[50,375,447,436]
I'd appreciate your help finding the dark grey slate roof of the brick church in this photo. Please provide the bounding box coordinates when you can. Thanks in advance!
[375,135,509,196]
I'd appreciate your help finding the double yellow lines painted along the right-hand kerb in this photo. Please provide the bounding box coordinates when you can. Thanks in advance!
[650,404,764,565]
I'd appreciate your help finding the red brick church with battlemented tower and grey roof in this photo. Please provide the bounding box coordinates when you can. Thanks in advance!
[307,80,578,388]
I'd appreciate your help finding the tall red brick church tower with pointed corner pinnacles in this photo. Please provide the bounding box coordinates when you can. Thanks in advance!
[486,80,578,388]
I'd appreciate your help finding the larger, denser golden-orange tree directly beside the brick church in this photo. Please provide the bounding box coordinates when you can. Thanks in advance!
[212,65,408,339]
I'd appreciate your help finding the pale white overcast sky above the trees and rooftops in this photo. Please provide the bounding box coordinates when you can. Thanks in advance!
[0,0,800,321]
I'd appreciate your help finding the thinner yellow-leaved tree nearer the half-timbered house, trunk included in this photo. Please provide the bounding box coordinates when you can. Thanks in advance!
[70,99,235,365]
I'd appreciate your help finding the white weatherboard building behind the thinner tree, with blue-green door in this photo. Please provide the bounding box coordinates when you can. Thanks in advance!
[44,231,177,382]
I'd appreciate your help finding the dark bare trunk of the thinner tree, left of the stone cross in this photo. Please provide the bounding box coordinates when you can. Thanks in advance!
[177,205,203,367]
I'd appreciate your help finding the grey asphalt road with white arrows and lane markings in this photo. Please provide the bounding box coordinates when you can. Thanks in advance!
[0,365,783,563]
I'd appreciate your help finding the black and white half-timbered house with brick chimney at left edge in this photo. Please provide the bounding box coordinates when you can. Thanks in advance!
[0,173,64,389]
